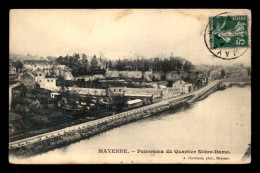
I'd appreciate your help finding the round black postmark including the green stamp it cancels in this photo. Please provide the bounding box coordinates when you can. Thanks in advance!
[204,12,250,60]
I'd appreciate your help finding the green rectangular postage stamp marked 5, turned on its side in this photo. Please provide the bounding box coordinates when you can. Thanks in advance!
[209,15,249,49]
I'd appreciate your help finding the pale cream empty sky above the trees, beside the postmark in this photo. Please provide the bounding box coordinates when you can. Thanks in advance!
[9,9,251,65]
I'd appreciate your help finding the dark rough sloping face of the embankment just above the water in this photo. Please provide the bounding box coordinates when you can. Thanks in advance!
[9,102,188,157]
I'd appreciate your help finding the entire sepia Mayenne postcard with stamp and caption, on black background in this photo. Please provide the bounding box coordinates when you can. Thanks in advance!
[8,9,252,164]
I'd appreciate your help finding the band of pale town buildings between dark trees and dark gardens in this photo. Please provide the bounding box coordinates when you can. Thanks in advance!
[9,55,251,115]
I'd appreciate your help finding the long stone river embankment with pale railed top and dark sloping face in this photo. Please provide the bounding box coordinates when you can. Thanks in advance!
[9,81,219,157]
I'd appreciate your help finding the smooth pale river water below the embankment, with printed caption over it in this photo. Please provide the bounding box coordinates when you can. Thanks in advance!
[10,86,251,164]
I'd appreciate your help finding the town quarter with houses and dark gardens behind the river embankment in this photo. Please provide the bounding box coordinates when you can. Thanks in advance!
[9,56,251,143]
